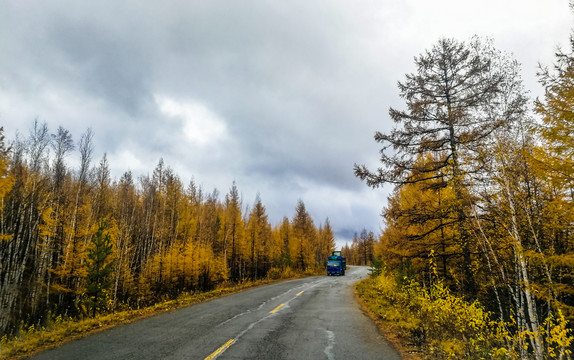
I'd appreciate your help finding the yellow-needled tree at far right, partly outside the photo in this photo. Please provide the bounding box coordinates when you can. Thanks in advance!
[530,22,574,321]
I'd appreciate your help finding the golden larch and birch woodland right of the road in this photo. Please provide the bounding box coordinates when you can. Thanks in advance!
[355,16,574,359]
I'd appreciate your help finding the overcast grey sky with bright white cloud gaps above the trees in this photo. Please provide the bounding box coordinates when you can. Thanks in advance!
[0,0,574,246]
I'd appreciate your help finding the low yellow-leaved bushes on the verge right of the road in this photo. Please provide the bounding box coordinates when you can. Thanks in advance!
[356,274,574,359]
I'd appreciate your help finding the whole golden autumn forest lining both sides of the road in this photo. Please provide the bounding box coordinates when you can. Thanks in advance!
[0,6,574,360]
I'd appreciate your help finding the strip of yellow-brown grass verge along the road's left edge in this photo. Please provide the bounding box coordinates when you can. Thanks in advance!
[0,269,323,360]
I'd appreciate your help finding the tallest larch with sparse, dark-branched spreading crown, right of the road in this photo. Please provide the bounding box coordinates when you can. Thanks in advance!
[355,38,526,298]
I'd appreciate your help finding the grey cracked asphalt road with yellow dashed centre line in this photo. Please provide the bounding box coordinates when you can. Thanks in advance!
[31,266,400,360]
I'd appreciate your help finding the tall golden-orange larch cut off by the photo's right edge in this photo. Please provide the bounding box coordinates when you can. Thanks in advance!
[519,21,574,356]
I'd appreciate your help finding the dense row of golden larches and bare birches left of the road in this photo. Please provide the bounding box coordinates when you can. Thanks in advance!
[0,125,335,337]
